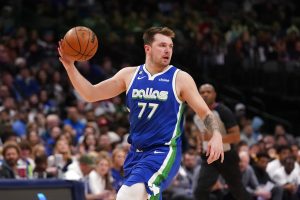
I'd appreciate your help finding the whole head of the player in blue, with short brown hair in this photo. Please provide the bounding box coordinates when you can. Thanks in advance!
[143,27,175,66]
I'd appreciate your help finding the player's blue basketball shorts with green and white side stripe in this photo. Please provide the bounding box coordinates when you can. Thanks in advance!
[123,146,181,200]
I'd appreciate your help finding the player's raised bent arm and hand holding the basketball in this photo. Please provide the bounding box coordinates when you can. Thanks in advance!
[58,40,134,102]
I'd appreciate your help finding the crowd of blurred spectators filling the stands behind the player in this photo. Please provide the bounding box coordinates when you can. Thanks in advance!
[0,0,300,199]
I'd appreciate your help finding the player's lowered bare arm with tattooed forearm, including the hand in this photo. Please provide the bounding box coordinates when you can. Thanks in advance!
[176,71,224,164]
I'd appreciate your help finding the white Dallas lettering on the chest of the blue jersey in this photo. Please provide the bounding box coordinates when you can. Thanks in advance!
[132,88,168,101]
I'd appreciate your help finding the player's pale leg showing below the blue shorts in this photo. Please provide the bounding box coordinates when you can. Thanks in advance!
[116,183,148,200]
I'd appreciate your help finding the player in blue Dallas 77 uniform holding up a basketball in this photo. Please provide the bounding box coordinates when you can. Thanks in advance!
[58,27,224,200]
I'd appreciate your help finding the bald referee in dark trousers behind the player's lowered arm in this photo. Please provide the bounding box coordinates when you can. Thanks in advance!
[194,84,250,200]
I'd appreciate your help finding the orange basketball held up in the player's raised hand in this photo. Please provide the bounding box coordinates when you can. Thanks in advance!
[61,26,98,61]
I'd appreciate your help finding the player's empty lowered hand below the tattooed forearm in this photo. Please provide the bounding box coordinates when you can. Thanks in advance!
[206,132,224,164]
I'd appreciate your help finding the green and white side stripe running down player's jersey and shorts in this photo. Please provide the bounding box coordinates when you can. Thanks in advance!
[148,104,184,199]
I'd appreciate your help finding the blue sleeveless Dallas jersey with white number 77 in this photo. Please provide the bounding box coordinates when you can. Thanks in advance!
[126,65,184,149]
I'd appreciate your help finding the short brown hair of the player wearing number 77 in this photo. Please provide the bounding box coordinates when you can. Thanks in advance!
[143,27,175,45]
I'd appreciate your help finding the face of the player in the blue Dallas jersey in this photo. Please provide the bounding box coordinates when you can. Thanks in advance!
[146,34,173,67]
